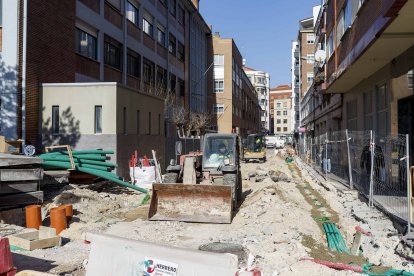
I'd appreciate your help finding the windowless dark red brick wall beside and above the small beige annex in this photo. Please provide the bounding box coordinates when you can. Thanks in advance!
[26,0,76,145]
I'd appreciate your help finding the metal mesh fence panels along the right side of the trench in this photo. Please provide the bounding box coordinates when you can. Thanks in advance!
[299,130,412,232]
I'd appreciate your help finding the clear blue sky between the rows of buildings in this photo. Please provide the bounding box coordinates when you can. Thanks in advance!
[200,0,321,88]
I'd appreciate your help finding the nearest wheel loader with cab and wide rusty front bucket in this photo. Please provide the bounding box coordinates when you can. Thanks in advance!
[148,134,242,223]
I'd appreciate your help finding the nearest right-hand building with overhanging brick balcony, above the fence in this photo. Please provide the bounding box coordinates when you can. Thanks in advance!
[321,0,414,160]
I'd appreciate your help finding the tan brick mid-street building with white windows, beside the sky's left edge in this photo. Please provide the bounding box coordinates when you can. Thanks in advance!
[209,34,260,136]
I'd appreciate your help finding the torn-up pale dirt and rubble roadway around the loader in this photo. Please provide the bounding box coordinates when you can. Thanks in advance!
[4,151,414,276]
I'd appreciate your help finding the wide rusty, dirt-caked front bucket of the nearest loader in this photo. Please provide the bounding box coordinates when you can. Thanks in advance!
[148,184,233,223]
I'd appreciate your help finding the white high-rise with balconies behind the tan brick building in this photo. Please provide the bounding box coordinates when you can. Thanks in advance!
[243,66,271,131]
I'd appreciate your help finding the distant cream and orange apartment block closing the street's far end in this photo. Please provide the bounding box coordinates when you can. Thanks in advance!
[270,85,295,135]
